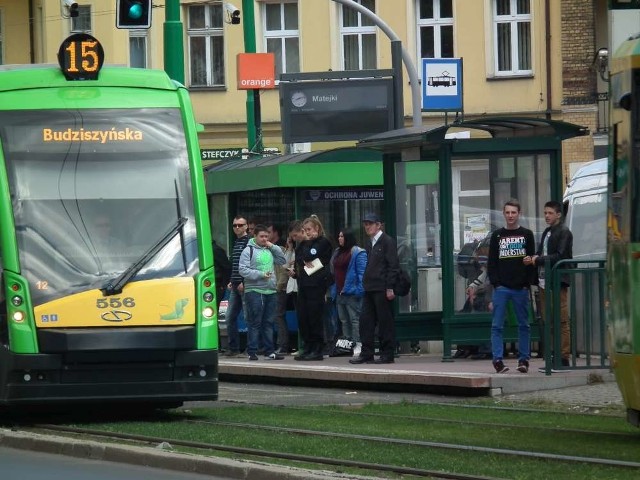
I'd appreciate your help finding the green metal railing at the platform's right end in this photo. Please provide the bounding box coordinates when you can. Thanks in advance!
[543,260,609,375]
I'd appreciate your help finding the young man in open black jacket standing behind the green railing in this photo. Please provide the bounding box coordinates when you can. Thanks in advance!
[524,200,573,367]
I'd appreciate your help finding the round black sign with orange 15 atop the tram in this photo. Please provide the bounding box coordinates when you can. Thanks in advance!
[58,33,104,81]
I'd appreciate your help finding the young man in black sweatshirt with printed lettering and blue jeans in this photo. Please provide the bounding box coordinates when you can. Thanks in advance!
[487,199,537,373]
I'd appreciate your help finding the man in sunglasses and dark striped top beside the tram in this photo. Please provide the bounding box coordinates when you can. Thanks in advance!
[225,216,249,357]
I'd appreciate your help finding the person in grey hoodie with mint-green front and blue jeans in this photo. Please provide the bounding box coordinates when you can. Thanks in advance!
[238,225,287,360]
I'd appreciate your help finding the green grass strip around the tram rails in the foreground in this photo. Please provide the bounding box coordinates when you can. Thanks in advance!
[70,403,640,480]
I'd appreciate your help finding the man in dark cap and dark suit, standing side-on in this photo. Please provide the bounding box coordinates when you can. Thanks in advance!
[349,213,400,365]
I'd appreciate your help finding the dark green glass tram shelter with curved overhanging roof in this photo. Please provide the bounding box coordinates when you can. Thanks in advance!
[357,117,588,360]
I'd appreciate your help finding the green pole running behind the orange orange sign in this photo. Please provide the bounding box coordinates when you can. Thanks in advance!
[242,0,264,153]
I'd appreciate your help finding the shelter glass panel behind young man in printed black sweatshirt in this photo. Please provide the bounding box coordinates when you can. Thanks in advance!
[451,154,551,313]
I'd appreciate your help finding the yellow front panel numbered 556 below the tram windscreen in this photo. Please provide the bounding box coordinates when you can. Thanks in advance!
[34,277,196,328]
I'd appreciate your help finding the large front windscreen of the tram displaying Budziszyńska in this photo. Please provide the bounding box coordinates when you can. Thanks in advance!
[0,109,198,305]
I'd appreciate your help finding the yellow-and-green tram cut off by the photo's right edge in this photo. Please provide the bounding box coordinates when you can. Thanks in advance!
[606,35,640,426]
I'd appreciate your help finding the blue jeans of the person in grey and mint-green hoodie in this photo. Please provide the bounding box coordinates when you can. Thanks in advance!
[244,292,278,356]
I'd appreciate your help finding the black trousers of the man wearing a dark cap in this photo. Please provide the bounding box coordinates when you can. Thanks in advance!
[360,291,396,358]
